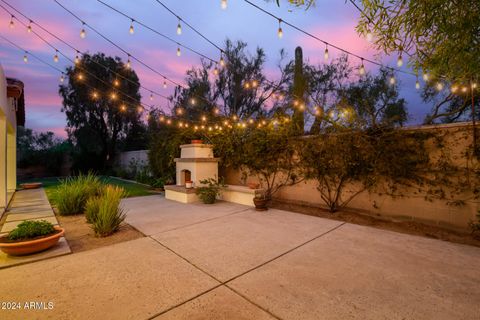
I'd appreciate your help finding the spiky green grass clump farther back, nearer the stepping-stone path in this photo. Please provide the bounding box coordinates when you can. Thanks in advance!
[53,173,102,215]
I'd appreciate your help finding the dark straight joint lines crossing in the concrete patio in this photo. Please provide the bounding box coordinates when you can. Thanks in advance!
[148,221,346,320]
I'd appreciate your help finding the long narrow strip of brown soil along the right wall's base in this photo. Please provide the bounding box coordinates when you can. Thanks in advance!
[270,201,480,247]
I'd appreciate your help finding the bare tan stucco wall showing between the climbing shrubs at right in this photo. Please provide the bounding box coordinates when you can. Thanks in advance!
[224,123,479,230]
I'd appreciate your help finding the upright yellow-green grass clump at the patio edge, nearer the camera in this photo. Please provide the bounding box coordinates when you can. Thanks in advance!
[89,185,126,237]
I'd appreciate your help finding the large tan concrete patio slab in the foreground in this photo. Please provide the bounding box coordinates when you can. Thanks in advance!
[0,196,480,319]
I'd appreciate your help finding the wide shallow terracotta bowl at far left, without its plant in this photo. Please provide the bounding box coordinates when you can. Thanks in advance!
[0,226,65,256]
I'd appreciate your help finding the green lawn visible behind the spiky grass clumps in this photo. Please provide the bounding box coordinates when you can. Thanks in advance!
[18,176,154,200]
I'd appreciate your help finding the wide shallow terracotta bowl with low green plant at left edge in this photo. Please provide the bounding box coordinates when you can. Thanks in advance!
[0,220,65,256]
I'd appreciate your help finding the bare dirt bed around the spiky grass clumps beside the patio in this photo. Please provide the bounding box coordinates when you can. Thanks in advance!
[57,214,144,253]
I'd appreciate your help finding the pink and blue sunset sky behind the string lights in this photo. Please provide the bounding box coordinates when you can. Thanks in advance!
[0,0,430,137]
